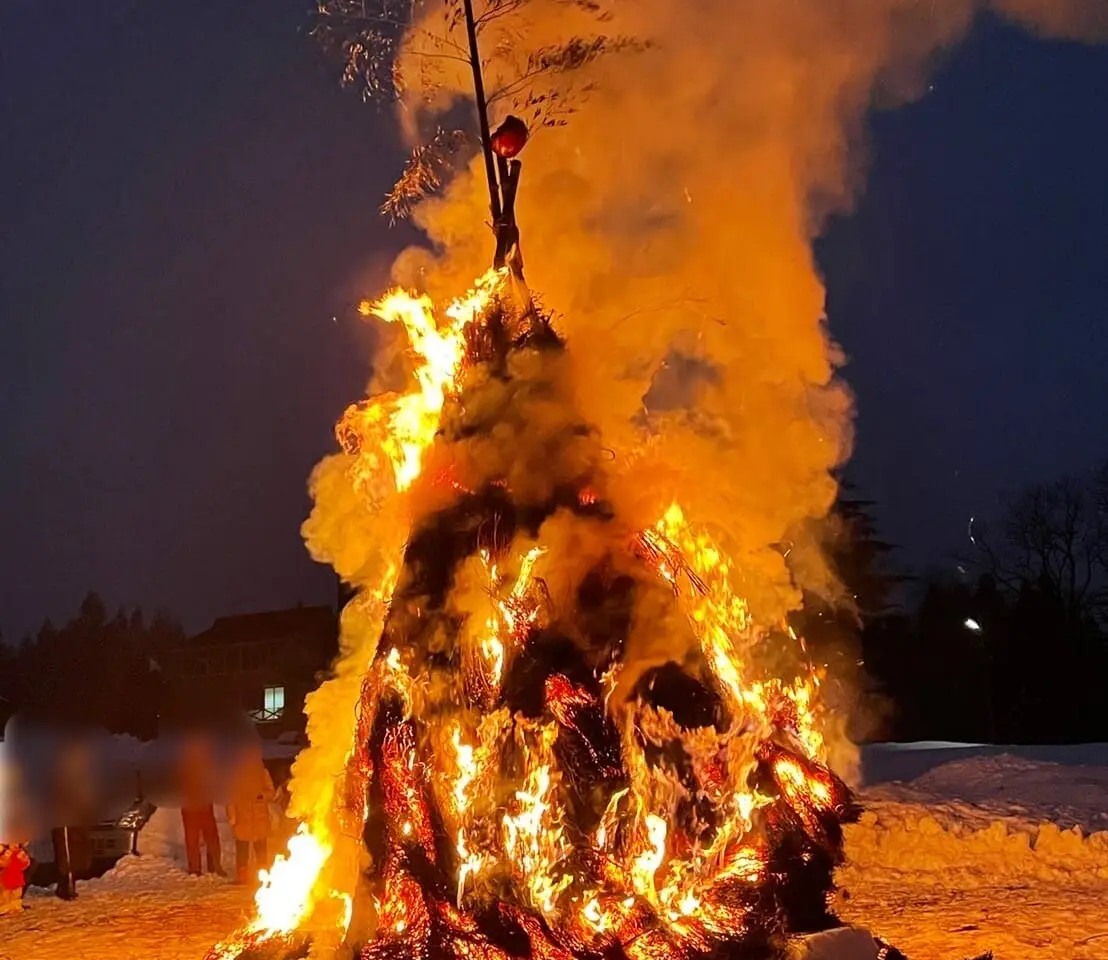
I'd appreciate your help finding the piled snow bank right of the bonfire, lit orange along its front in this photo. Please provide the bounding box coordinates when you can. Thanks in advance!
[845,755,1108,885]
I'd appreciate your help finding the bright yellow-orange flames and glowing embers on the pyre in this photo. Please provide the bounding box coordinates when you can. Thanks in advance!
[209,272,837,960]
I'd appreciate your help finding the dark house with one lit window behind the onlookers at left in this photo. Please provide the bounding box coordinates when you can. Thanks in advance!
[163,606,338,738]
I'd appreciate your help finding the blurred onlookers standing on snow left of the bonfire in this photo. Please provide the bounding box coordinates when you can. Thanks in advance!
[0,733,290,913]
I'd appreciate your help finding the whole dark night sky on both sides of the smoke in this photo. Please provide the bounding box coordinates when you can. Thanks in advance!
[0,0,1108,640]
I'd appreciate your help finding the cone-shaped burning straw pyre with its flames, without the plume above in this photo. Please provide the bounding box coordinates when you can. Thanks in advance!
[203,273,992,960]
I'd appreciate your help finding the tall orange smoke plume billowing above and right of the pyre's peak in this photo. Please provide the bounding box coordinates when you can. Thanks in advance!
[396,0,1108,619]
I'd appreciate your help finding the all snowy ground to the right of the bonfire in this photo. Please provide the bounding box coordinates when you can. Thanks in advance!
[835,745,1108,960]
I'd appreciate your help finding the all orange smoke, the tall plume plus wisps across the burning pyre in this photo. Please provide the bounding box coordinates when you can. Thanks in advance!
[294,0,1108,926]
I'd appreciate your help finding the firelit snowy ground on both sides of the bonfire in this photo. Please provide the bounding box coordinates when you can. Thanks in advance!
[0,744,1108,960]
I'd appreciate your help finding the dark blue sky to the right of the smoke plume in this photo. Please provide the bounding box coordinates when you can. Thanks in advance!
[818,19,1108,569]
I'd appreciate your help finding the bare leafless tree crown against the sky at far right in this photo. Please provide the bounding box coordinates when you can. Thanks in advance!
[970,467,1108,625]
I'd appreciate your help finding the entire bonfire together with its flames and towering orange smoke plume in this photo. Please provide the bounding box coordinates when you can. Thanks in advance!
[192,0,1099,960]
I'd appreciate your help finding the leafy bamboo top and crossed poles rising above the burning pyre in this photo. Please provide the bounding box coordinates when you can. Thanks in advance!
[311,0,643,267]
